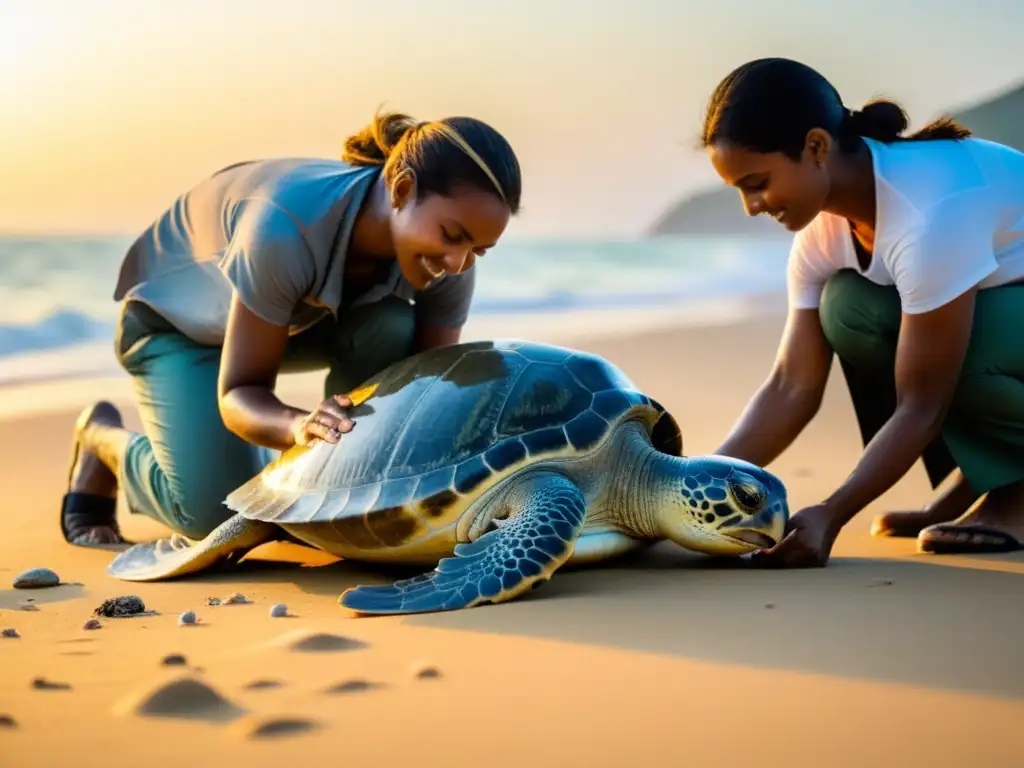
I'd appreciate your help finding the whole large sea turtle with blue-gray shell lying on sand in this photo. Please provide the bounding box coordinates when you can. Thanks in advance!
[109,340,788,613]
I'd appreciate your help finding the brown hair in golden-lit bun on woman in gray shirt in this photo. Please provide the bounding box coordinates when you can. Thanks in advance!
[341,113,522,214]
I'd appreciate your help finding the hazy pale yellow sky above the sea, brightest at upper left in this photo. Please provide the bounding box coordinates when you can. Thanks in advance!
[0,0,1024,238]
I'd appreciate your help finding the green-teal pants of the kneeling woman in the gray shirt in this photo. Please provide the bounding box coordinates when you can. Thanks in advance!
[117,297,415,539]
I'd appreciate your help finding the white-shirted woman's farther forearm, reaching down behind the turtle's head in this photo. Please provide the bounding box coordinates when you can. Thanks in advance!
[715,379,821,467]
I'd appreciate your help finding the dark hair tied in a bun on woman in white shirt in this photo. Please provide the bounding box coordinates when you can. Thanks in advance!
[701,58,971,160]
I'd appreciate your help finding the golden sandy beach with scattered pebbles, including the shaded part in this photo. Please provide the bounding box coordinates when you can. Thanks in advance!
[0,312,1024,768]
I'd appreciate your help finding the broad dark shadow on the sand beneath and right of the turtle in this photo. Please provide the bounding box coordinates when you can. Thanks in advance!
[169,544,1024,699]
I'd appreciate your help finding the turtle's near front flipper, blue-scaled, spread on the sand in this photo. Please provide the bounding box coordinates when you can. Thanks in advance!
[339,472,587,613]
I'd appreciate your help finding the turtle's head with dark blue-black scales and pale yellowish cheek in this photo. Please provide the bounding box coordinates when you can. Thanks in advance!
[659,456,790,555]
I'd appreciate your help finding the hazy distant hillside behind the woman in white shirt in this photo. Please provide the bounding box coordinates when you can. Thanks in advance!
[649,83,1024,238]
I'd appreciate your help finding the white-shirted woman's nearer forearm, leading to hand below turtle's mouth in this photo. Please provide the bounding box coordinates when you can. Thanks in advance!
[824,407,943,528]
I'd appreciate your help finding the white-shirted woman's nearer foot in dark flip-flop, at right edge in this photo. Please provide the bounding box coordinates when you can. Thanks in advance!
[918,481,1024,553]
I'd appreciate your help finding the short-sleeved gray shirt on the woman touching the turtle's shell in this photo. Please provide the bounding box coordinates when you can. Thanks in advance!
[114,159,475,345]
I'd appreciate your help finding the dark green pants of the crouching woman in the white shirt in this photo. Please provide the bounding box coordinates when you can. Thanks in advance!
[819,269,1024,494]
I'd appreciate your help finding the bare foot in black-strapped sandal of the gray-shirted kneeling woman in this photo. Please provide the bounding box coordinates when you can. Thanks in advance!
[65,401,124,547]
